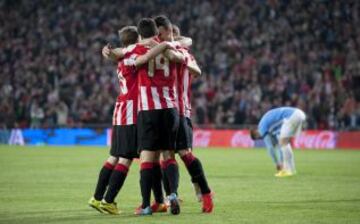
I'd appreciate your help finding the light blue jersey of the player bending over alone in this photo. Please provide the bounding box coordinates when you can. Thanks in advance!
[258,107,297,138]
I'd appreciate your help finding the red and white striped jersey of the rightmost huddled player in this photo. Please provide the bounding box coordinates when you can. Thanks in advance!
[177,48,195,118]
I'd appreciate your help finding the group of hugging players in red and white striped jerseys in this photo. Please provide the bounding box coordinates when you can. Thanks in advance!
[89,16,214,215]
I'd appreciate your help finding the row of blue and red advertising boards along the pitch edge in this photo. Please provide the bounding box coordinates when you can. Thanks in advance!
[0,128,360,149]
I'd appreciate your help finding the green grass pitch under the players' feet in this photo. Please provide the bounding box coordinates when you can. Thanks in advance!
[0,145,360,224]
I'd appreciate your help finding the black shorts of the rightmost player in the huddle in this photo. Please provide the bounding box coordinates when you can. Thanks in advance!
[176,116,193,151]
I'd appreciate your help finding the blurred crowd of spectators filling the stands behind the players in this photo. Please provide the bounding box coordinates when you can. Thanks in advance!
[0,0,360,130]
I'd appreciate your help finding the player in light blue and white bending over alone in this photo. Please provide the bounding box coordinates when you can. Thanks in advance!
[250,107,306,177]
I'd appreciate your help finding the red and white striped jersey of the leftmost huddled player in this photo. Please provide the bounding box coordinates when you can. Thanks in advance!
[113,45,138,125]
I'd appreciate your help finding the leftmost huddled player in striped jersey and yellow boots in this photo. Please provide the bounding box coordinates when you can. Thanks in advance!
[89,26,176,214]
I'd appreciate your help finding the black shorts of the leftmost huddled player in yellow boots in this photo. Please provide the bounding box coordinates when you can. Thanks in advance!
[110,124,139,159]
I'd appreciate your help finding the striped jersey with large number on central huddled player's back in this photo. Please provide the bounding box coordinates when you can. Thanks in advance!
[131,45,177,111]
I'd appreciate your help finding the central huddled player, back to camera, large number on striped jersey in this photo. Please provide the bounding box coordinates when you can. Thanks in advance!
[135,18,184,215]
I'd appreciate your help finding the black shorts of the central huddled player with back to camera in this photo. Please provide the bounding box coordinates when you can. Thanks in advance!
[137,108,179,151]
